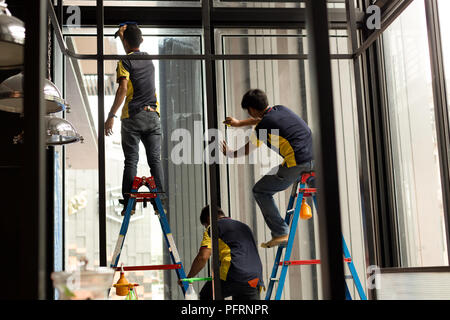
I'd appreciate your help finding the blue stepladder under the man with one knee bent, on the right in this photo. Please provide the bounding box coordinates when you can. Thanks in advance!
[266,172,367,300]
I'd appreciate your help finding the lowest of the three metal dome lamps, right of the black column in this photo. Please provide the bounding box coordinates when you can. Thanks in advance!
[45,116,84,145]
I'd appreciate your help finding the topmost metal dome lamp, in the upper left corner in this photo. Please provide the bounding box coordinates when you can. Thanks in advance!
[0,0,25,70]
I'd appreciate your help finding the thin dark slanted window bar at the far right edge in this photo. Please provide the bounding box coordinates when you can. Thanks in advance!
[425,0,450,261]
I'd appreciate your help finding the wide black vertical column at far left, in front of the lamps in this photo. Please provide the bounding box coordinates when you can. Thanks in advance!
[21,0,50,299]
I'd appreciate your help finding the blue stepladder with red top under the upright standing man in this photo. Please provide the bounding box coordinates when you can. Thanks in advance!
[110,177,189,294]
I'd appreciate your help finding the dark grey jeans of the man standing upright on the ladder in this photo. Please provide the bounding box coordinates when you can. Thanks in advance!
[121,110,165,207]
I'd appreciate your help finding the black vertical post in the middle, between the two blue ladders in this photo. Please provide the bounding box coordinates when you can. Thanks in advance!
[202,0,223,300]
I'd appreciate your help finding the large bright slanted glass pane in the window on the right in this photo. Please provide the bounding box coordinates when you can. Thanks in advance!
[383,1,448,267]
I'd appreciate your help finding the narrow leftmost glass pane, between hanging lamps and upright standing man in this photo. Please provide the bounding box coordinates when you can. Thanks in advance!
[64,59,100,270]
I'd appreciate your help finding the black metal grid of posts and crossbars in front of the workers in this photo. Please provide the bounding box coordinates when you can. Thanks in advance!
[48,0,358,300]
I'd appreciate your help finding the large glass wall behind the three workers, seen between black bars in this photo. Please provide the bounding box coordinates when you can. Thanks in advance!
[57,1,365,300]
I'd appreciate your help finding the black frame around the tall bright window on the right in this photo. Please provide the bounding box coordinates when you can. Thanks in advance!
[355,0,450,270]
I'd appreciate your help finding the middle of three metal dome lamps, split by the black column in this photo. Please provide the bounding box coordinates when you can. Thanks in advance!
[0,72,69,114]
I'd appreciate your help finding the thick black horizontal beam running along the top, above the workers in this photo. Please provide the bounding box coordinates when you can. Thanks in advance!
[55,6,364,29]
